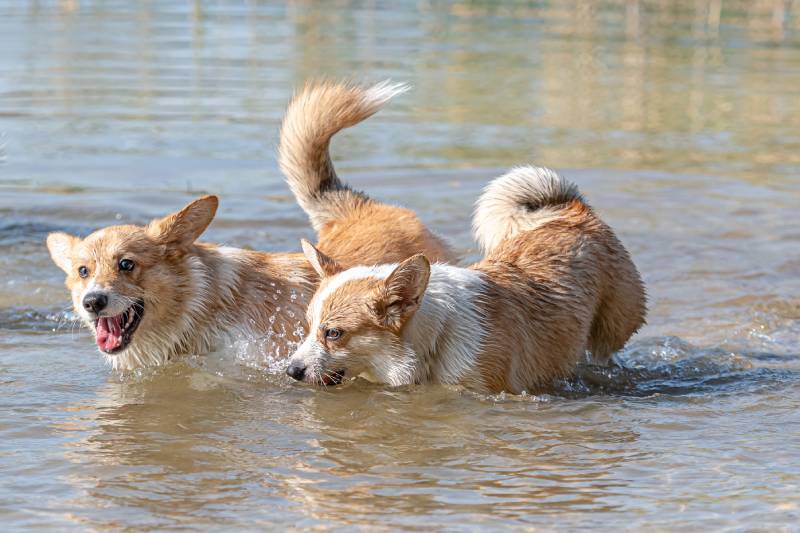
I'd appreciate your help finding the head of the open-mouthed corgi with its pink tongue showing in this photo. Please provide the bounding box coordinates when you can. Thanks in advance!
[47,196,218,360]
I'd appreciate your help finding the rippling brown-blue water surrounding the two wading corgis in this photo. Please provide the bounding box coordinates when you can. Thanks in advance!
[0,0,800,531]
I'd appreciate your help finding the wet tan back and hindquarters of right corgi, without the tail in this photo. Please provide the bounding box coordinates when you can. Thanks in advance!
[471,200,644,392]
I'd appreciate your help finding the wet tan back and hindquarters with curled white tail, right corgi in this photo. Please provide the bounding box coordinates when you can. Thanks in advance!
[473,167,646,390]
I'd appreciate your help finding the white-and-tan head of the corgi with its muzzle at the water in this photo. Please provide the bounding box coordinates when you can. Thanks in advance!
[286,241,430,385]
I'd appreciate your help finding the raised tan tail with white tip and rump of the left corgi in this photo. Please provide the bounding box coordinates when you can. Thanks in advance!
[278,82,455,264]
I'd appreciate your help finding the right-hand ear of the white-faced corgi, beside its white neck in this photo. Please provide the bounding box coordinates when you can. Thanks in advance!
[375,254,431,330]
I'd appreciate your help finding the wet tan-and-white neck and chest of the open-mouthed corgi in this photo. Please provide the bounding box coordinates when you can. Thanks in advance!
[112,244,316,370]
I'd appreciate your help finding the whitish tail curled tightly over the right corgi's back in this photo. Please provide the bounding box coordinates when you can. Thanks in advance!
[472,166,583,254]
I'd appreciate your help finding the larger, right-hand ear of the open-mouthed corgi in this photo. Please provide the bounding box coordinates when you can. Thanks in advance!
[147,195,219,248]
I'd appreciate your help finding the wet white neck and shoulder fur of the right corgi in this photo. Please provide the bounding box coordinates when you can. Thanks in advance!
[372,264,486,385]
